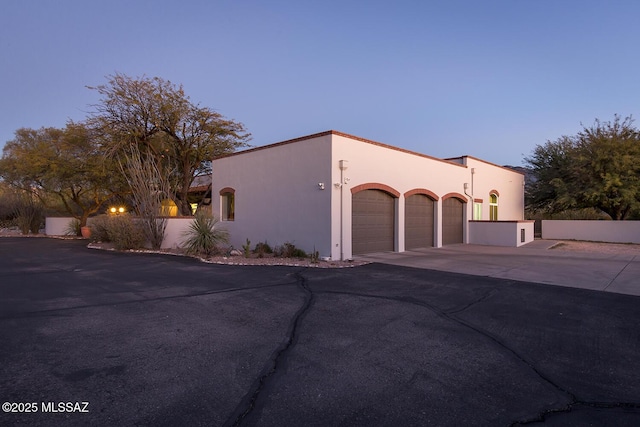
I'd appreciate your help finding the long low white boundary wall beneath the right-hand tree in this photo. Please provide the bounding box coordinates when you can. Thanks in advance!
[542,220,640,244]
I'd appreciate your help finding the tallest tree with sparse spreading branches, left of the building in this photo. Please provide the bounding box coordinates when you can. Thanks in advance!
[91,74,251,215]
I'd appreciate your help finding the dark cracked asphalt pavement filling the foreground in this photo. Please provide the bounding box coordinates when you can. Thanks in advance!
[0,238,640,426]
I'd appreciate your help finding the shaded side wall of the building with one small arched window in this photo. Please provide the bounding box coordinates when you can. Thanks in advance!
[212,135,332,257]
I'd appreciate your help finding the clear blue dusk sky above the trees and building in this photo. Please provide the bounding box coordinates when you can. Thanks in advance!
[0,0,640,165]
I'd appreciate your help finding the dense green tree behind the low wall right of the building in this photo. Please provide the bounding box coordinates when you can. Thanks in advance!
[525,115,640,220]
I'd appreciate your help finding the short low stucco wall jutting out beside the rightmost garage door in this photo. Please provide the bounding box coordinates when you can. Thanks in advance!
[469,221,535,247]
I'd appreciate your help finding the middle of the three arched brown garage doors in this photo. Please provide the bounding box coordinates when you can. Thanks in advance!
[404,194,433,250]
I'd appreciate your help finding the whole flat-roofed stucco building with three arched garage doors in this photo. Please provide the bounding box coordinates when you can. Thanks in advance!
[211,130,533,260]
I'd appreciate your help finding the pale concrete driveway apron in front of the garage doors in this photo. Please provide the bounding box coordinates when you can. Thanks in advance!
[357,240,640,295]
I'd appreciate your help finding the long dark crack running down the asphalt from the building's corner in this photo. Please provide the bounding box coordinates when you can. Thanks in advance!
[223,272,315,427]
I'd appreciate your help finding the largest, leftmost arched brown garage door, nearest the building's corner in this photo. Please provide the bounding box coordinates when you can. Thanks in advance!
[351,190,395,254]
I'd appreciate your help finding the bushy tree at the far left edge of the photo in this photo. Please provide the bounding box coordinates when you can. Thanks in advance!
[0,122,124,226]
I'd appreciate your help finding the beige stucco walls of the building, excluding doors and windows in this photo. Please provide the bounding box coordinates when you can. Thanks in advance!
[212,132,524,259]
